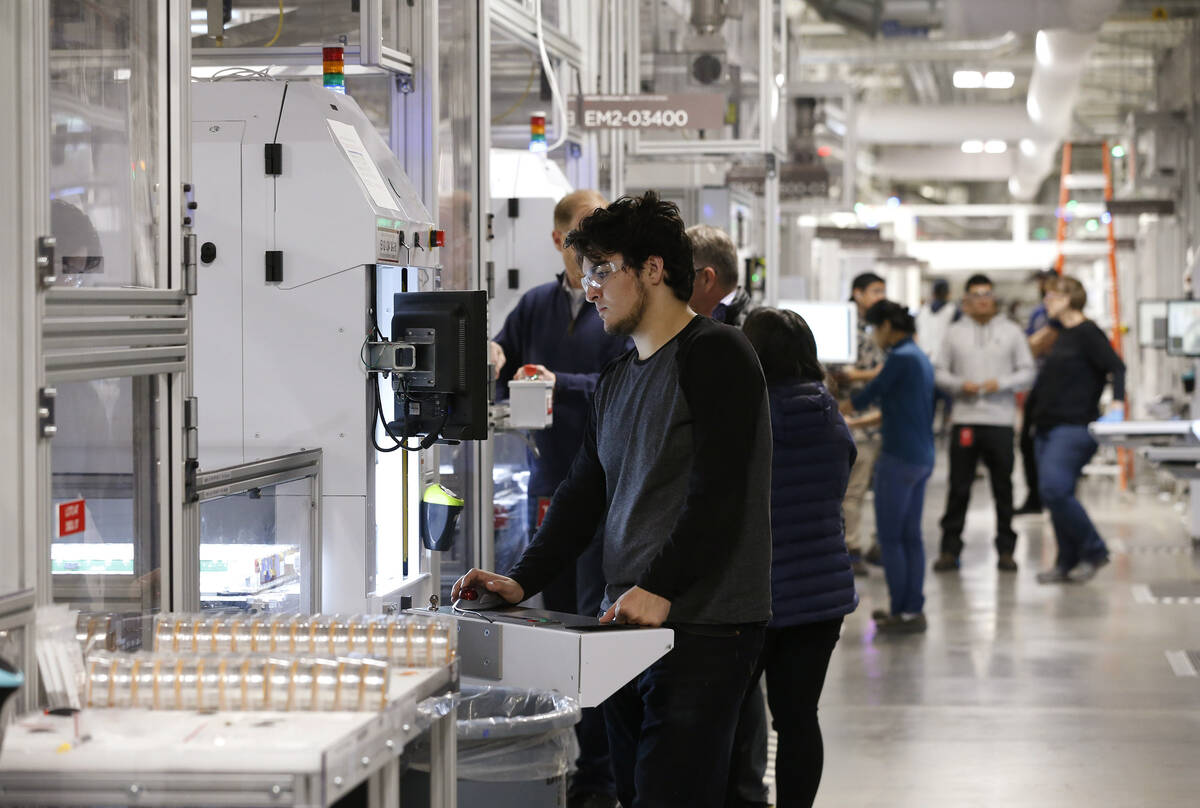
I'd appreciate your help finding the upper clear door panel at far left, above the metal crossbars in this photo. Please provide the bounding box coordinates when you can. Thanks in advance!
[49,0,164,287]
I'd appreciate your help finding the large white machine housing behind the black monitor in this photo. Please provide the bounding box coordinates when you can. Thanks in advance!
[192,82,439,612]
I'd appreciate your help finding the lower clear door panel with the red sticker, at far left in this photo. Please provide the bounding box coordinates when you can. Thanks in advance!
[50,377,162,634]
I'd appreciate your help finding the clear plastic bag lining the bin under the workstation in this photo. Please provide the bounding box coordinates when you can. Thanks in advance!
[413,688,580,783]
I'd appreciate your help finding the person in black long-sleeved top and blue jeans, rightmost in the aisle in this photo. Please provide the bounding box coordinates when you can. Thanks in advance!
[1030,277,1124,583]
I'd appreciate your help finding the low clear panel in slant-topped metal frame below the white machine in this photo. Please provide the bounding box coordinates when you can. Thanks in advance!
[200,478,314,614]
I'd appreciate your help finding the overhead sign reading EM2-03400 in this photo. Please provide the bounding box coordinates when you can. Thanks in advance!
[566,92,726,130]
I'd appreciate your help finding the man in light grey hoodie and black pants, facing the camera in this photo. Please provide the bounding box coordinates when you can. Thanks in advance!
[934,275,1036,573]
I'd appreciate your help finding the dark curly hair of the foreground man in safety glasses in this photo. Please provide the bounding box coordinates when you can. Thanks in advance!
[563,191,696,300]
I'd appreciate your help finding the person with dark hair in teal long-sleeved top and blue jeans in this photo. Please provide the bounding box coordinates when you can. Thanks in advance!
[851,300,934,634]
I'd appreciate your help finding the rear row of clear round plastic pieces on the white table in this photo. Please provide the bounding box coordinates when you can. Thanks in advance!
[154,614,458,668]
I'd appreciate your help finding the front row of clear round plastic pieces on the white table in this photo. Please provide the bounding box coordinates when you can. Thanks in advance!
[84,651,390,712]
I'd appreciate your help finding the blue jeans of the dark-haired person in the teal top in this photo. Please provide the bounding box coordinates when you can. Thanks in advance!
[875,454,934,615]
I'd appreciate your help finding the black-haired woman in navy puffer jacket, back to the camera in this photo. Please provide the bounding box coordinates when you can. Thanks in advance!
[727,309,858,808]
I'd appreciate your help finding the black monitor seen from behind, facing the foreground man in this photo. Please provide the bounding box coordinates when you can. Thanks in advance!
[389,291,488,441]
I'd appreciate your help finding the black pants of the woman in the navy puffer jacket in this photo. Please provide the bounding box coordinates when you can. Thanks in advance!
[725,617,842,808]
